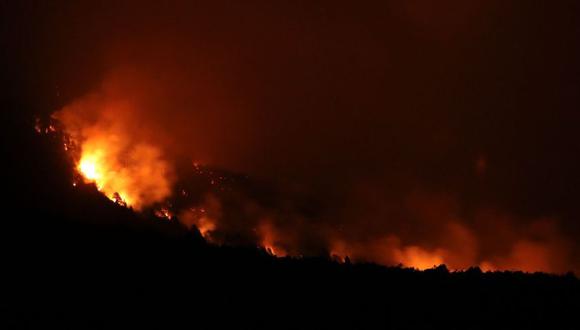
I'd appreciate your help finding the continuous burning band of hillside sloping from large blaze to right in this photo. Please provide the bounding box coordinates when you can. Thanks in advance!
[37,75,569,272]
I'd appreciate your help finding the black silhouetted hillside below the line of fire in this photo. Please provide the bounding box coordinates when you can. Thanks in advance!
[1,113,580,329]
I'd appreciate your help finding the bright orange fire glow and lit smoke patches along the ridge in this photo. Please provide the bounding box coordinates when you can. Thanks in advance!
[49,88,569,272]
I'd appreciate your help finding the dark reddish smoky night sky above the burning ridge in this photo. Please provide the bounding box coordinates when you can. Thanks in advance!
[0,0,580,269]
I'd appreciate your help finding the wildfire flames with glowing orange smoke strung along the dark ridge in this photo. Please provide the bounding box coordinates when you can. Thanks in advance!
[34,90,567,271]
